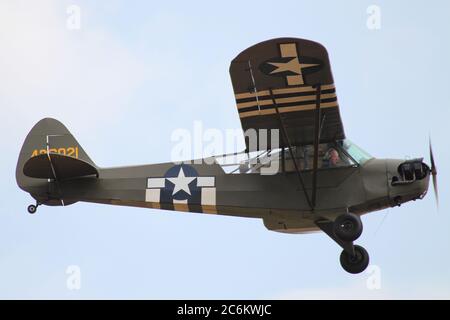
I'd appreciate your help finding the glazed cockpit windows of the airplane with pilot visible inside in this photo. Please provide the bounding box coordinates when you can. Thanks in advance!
[215,139,372,174]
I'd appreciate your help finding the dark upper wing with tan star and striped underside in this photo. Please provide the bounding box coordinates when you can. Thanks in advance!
[230,38,345,151]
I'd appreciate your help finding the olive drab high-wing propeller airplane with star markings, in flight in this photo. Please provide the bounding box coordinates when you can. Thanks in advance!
[16,38,437,273]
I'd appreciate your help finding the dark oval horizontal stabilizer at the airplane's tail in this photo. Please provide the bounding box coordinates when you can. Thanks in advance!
[23,153,98,180]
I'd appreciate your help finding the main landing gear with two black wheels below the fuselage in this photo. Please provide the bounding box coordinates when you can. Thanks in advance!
[315,213,369,274]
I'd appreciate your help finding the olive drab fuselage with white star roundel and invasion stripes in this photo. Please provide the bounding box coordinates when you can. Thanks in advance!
[22,158,429,232]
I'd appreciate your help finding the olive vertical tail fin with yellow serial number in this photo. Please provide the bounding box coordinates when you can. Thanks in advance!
[16,118,97,191]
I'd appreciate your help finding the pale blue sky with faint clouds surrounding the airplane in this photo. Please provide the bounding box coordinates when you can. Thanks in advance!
[0,0,450,299]
